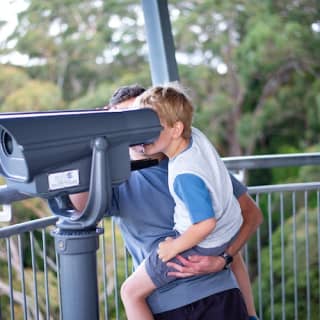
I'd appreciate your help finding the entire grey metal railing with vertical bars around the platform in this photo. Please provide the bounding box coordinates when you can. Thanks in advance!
[0,154,320,320]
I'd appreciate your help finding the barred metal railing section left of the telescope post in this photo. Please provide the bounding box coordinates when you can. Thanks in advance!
[0,217,59,319]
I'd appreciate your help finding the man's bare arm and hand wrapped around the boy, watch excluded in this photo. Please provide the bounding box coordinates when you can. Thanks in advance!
[168,193,263,278]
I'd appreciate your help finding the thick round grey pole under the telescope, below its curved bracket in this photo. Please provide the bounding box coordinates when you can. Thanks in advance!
[53,229,103,320]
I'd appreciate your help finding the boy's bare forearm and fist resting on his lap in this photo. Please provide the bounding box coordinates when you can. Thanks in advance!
[158,218,216,262]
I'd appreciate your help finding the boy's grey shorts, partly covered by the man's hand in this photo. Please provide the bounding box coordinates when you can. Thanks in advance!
[145,232,234,288]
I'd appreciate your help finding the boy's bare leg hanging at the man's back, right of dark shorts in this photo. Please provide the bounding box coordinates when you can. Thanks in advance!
[231,253,257,316]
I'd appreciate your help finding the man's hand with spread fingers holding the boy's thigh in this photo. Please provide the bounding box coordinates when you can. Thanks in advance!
[167,255,226,278]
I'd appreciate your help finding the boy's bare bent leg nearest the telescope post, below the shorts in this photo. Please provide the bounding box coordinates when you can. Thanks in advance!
[121,263,156,320]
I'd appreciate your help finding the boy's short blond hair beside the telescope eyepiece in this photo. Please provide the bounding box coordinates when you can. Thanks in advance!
[138,83,194,139]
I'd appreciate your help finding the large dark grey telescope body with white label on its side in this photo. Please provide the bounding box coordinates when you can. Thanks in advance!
[0,109,162,198]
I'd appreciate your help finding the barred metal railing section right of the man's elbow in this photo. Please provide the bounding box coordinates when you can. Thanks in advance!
[244,182,320,320]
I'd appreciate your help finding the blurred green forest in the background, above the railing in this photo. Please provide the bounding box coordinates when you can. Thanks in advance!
[0,0,320,318]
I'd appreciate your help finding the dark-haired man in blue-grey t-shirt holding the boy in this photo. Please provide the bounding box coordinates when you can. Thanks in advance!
[71,86,262,320]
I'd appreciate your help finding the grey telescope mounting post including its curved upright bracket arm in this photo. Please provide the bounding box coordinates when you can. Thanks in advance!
[52,137,112,320]
